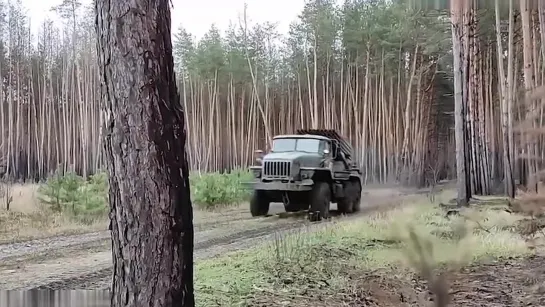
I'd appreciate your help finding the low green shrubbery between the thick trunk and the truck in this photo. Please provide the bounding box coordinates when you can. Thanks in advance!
[189,169,252,209]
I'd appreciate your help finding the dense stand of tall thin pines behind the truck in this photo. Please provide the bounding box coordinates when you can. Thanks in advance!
[0,0,545,194]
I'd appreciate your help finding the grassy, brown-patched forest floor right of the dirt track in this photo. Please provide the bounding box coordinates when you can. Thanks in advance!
[196,191,545,307]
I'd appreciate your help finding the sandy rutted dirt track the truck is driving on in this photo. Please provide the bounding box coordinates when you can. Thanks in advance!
[0,188,416,290]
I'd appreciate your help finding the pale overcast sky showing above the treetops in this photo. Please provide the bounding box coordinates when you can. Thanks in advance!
[22,0,305,38]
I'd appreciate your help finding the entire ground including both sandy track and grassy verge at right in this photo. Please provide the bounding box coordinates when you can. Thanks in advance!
[0,184,545,307]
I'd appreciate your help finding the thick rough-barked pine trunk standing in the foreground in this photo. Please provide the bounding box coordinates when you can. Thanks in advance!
[96,0,194,307]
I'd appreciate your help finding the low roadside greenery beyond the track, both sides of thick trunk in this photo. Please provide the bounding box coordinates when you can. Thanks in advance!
[0,169,252,243]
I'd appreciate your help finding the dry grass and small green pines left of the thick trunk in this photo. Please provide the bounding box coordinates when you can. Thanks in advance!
[0,173,108,243]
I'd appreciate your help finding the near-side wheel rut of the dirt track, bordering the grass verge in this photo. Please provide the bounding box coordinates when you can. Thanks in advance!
[19,193,414,290]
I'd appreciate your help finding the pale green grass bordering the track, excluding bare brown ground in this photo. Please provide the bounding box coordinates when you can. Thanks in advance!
[196,193,530,306]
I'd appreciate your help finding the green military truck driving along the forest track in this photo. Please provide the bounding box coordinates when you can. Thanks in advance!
[246,129,362,221]
